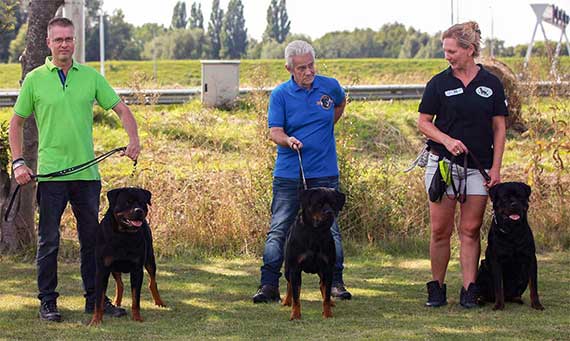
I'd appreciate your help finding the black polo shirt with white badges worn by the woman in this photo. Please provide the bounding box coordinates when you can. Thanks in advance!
[418,64,508,168]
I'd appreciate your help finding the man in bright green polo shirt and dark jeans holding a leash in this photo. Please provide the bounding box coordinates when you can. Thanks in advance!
[9,18,140,322]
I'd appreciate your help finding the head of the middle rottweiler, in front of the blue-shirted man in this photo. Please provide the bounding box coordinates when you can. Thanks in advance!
[301,187,346,228]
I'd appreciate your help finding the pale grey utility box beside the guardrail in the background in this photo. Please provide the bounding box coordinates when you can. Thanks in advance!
[201,60,240,108]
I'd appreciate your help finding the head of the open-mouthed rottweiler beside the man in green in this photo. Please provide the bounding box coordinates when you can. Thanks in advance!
[107,187,151,232]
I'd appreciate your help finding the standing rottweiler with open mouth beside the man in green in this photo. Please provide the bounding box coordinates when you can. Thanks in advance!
[90,187,166,325]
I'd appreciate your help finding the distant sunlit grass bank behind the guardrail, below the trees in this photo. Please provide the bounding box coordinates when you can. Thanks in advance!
[0,57,570,89]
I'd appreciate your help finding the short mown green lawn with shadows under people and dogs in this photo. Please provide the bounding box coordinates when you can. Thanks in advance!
[0,248,570,340]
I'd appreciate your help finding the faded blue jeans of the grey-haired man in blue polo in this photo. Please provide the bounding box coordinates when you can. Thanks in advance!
[261,176,344,286]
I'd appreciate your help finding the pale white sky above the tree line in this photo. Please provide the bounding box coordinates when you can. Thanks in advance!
[103,0,570,46]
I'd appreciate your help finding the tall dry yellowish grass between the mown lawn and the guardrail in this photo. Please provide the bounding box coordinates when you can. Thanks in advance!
[46,65,570,256]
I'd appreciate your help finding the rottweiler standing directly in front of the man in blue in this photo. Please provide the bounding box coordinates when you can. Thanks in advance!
[283,187,345,320]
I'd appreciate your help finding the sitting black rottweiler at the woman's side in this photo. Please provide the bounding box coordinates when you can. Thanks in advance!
[477,182,544,310]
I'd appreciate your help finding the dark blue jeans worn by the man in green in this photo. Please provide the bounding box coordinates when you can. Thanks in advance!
[36,180,101,302]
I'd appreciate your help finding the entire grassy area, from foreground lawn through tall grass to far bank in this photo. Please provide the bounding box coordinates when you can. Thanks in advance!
[0,59,570,340]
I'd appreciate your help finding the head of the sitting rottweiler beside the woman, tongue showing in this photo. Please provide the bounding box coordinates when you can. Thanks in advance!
[489,182,531,225]
